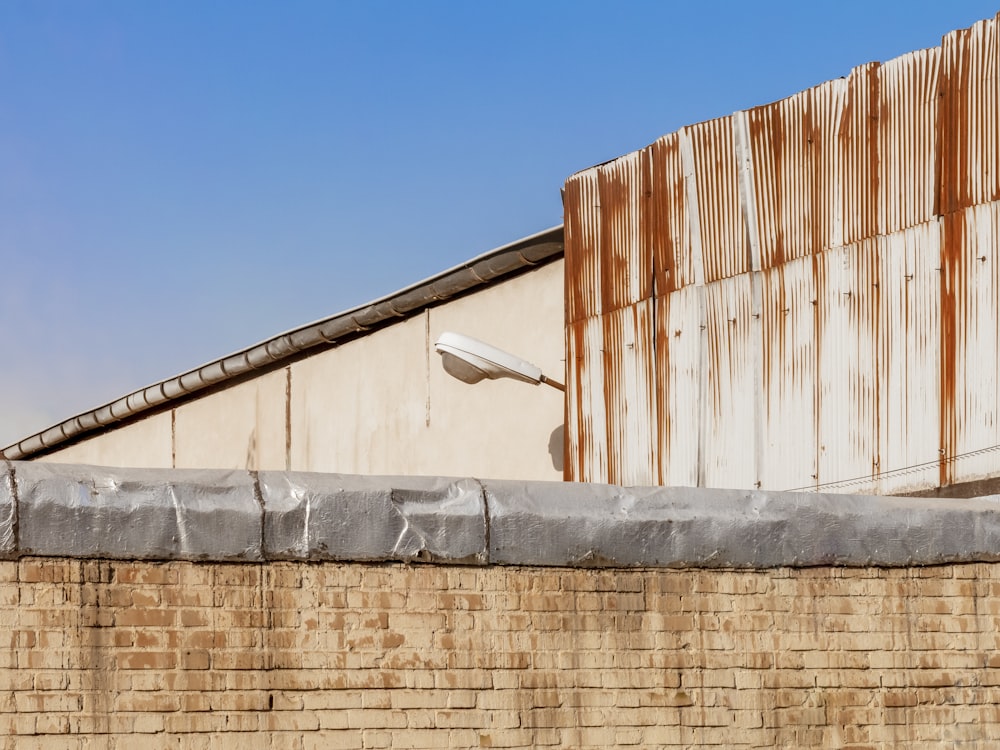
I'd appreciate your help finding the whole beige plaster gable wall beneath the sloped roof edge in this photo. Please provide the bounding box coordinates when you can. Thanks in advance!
[40,260,565,480]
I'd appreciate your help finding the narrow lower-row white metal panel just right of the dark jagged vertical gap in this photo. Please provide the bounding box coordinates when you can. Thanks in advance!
[656,286,704,487]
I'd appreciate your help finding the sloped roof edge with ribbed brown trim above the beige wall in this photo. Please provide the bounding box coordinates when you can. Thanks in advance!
[0,225,563,460]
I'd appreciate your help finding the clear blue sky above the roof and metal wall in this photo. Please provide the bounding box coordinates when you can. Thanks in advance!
[0,0,998,447]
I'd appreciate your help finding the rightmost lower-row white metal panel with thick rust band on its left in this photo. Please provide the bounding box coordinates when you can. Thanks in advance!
[940,203,1000,483]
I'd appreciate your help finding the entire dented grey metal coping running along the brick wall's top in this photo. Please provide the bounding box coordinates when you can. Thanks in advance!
[0,462,1000,568]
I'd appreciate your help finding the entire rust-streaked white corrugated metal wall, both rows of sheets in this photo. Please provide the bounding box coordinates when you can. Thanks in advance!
[564,15,1000,494]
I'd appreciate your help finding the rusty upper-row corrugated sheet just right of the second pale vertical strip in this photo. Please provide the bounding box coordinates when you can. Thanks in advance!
[746,80,846,268]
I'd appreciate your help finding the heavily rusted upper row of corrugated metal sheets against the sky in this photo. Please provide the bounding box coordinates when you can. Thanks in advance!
[566,19,988,282]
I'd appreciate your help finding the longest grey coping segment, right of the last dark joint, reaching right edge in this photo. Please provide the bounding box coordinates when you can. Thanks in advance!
[486,482,1000,568]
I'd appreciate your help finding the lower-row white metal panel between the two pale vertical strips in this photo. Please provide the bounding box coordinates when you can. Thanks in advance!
[703,274,757,487]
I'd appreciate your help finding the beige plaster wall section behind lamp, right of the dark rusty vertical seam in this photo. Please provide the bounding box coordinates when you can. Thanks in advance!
[289,261,564,479]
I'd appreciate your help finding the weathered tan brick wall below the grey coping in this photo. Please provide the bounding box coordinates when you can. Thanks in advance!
[0,558,1000,750]
